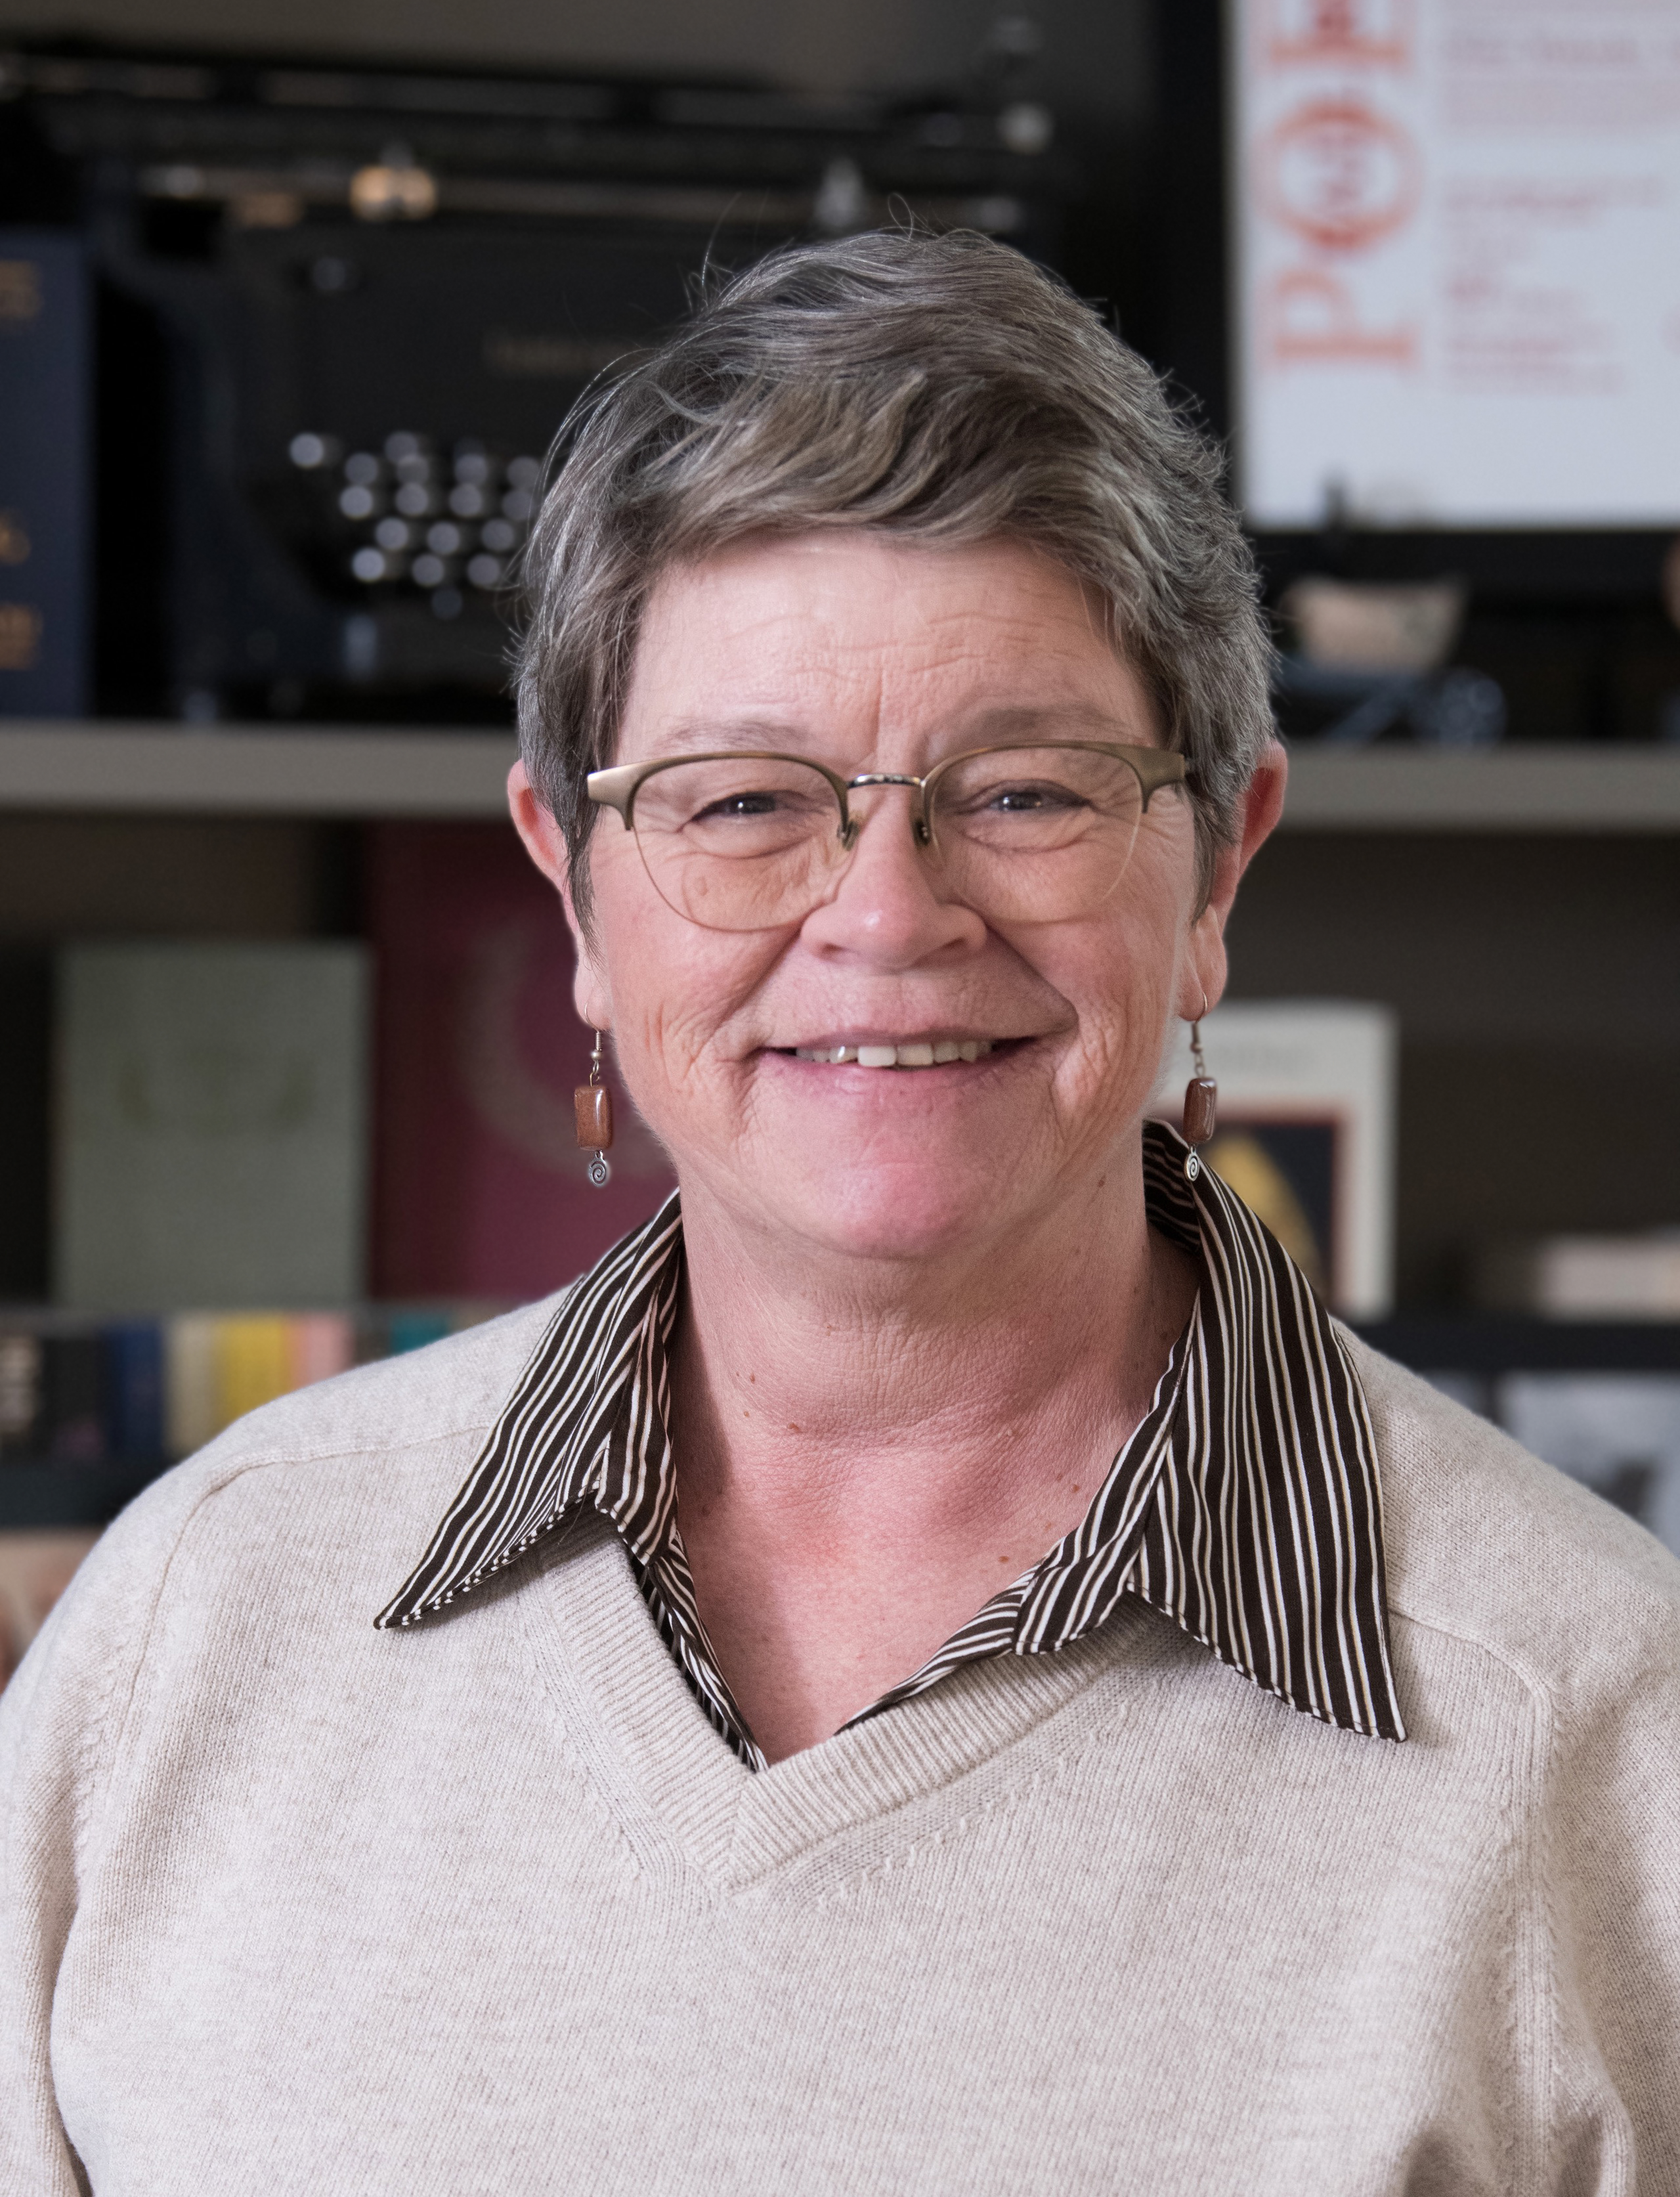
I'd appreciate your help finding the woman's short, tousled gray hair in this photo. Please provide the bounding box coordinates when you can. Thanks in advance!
[518,230,1272,909]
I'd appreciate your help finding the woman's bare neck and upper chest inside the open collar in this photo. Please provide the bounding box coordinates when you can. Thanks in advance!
[672,1167,1195,1760]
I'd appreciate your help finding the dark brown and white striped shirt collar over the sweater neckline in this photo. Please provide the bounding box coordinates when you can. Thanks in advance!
[376,1123,1406,1769]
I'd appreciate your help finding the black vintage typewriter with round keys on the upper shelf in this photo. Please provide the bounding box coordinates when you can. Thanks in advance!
[0,42,1065,723]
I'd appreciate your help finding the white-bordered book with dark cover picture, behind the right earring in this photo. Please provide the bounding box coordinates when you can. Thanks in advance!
[1148,999,1399,1320]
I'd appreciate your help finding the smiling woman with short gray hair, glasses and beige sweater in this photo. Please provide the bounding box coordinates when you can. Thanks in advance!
[0,235,1680,2197]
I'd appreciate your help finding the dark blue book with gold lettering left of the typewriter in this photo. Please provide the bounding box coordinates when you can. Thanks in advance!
[0,228,92,716]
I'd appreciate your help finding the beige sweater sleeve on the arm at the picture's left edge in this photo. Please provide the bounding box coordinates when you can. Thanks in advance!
[0,1474,198,2197]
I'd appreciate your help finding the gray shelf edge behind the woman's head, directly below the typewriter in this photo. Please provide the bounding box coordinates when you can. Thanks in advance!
[0,718,1680,835]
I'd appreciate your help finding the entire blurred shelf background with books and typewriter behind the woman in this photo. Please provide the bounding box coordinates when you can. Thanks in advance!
[0,0,1680,1655]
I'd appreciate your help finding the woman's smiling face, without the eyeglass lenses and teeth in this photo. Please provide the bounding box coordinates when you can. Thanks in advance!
[527,532,1274,1259]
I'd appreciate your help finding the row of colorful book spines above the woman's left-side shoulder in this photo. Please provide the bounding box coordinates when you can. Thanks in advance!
[0,1305,485,1468]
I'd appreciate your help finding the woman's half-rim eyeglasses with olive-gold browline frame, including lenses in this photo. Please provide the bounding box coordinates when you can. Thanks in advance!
[586,741,1186,932]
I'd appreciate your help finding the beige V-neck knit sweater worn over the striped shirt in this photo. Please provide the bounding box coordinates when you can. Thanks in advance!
[0,1307,1680,2197]
